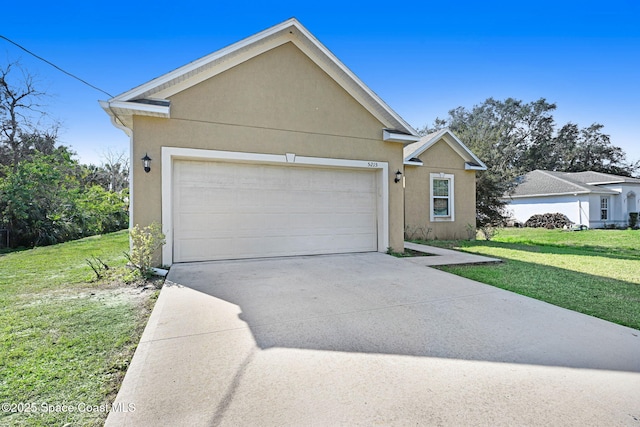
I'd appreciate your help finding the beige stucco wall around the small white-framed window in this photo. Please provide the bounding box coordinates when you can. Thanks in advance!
[404,140,476,240]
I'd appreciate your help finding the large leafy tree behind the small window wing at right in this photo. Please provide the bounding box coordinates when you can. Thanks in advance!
[421,98,640,227]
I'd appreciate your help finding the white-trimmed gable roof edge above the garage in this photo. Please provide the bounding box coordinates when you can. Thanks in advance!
[100,18,419,140]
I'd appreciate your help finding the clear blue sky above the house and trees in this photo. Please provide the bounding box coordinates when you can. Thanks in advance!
[0,0,640,163]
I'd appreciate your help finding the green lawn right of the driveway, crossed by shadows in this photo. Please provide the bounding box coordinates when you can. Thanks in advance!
[416,229,640,329]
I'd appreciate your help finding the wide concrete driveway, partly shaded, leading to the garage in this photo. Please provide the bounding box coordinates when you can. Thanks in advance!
[107,253,640,426]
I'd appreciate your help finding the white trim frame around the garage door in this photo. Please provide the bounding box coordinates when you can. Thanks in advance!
[161,147,389,265]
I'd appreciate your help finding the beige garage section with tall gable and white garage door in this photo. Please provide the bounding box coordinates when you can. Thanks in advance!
[100,19,422,265]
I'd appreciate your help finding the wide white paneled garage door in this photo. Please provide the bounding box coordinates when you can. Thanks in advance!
[173,160,378,262]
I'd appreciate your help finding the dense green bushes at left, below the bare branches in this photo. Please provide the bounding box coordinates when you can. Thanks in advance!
[0,147,128,247]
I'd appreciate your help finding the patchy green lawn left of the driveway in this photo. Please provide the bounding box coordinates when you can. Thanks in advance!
[0,231,157,426]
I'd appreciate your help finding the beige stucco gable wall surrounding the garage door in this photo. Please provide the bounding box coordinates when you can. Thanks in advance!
[132,43,404,258]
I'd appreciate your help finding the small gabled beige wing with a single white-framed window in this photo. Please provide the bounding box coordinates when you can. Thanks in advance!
[404,129,487,239]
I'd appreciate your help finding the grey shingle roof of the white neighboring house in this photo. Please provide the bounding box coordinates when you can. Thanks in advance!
[509,169,624,199]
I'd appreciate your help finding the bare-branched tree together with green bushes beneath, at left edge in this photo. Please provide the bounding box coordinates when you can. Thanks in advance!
[0,59,128,247]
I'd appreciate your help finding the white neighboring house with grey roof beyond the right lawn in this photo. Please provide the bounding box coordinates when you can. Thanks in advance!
[505,170,640,228]
